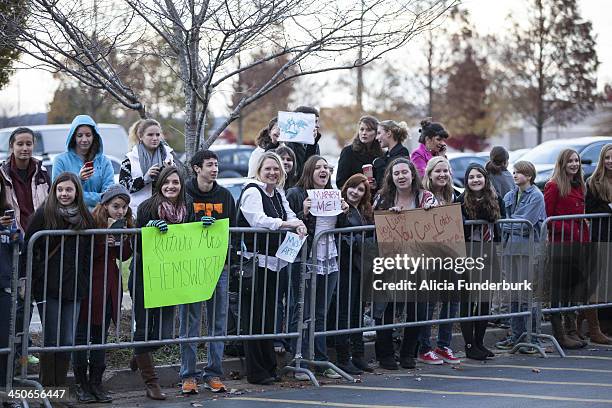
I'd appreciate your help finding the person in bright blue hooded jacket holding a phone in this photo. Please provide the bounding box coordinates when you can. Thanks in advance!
[52,115,114,211]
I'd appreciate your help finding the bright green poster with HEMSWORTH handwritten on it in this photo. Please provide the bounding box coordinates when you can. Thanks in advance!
[142,219,229,309]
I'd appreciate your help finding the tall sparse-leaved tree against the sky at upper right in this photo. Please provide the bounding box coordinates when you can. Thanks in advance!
[502,0,599,144]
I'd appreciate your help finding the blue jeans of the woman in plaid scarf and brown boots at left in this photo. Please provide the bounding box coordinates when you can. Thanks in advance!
[37,297,81,346]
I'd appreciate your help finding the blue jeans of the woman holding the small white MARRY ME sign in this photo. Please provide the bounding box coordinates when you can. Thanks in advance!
[292,272,338,361]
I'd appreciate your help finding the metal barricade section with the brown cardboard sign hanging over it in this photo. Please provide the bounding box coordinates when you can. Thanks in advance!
[301,219,545,384]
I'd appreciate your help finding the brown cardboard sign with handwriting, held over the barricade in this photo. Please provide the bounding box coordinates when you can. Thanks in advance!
[374,204,465,257]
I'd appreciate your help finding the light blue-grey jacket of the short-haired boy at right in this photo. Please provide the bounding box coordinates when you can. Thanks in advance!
[501,185,546,255]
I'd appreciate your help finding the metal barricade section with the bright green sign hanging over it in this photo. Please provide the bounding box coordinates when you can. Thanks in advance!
[16,228,307,404]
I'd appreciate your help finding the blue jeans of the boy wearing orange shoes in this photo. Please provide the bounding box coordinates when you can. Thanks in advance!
[179,269,228,378]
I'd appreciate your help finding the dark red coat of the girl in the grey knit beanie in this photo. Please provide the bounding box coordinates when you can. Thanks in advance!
[79,235,133,326]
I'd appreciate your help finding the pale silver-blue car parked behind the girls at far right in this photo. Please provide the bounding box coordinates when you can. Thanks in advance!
[521,136,612,189]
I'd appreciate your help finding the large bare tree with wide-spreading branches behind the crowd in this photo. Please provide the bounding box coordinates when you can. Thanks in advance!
[0,0,457,157]
